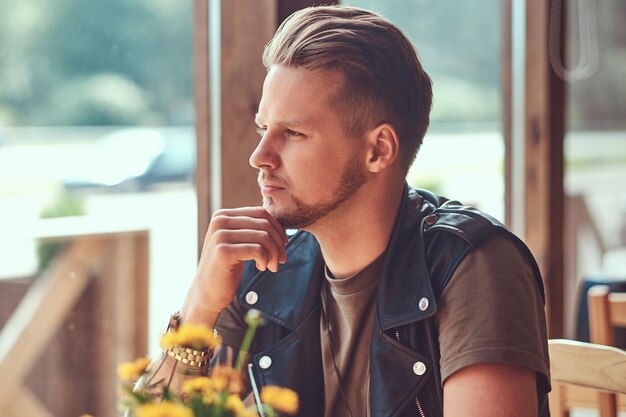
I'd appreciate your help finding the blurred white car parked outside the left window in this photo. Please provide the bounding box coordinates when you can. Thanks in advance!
[63,128,196,192]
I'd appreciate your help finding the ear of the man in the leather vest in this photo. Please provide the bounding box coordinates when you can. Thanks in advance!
[366,123,400,173]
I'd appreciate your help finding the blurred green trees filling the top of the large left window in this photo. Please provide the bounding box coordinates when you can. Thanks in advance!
[0,0,193,125]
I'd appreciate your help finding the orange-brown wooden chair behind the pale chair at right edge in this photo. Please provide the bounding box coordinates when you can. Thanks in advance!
[587,285,626,417]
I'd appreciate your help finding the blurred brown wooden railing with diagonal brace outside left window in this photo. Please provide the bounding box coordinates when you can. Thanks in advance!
[0,231,149,417]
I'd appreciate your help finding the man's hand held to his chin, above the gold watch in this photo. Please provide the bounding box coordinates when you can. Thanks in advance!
[181,207,288,327]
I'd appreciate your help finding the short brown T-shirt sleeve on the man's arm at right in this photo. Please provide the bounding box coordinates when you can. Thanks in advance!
[436,232,549,388]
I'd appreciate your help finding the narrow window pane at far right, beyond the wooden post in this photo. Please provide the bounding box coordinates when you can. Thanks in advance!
[553,0,626,346]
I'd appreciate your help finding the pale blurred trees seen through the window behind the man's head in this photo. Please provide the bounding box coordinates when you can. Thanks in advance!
[341,0,502,122]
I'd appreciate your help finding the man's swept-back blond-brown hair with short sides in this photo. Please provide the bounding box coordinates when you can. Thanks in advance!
[263,6,432,172]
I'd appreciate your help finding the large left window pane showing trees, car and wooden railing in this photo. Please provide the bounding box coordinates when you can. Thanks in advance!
[0,0,197,416]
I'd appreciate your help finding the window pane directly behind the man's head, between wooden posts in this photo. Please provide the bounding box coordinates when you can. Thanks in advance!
[341,0,504,220]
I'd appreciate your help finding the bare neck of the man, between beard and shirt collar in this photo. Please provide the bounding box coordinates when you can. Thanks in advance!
[308,178,403,279]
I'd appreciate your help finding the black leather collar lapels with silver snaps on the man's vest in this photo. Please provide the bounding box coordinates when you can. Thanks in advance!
[239,183,436,331]
